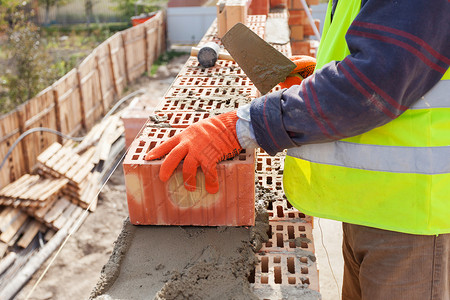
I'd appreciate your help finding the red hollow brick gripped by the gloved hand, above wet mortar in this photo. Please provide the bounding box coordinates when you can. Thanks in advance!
[123,127,255,226]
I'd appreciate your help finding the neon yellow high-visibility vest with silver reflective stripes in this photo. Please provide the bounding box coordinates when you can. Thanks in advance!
[284,0,450,234]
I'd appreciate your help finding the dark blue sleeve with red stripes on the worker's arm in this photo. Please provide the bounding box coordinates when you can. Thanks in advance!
[246,0,450,154]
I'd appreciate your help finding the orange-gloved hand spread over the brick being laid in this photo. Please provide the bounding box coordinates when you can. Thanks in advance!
[145,111,242,194]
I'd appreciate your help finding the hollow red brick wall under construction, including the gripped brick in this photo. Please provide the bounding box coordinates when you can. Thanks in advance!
[124,14,320,299]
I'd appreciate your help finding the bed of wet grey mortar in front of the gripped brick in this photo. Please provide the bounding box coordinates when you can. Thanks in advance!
[91,212,269,299]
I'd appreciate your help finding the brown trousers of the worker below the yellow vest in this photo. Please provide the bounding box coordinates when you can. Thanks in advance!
[342,223,450,300]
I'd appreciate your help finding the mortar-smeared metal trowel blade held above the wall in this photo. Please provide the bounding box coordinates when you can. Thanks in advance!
[222,23,295,95]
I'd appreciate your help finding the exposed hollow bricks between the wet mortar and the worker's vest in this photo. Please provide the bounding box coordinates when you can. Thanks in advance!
[250,149,320,299]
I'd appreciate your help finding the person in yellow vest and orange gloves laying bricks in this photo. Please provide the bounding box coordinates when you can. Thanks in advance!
[147,0,450,300]
